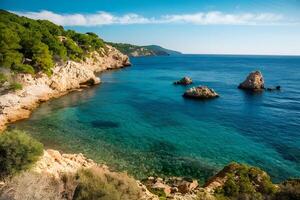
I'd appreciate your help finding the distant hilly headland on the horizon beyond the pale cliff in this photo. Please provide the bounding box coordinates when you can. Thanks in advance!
[107,42,181,57]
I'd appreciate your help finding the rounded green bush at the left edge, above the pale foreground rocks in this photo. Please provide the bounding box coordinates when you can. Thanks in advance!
[0,130,43,178]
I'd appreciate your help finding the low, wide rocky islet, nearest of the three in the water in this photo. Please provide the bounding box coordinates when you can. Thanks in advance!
[183,86,219,99]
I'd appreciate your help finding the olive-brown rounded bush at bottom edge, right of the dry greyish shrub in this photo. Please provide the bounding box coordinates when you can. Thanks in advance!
[73,167,142,200]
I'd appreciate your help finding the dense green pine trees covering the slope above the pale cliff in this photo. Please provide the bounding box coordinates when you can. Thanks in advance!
[0,10,105,78]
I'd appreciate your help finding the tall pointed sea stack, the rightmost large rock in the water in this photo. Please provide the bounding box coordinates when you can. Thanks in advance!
[238,71,265,91]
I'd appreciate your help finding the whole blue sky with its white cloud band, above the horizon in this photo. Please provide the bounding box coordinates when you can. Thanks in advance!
[0,0,300,55]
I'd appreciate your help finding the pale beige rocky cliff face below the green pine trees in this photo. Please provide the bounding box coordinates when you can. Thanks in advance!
[0,46,130,130]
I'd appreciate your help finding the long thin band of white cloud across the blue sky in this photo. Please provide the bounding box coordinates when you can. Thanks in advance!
[13,10,284,26]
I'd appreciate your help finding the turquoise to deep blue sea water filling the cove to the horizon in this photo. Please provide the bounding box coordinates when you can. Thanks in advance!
[8,55,300,181]
